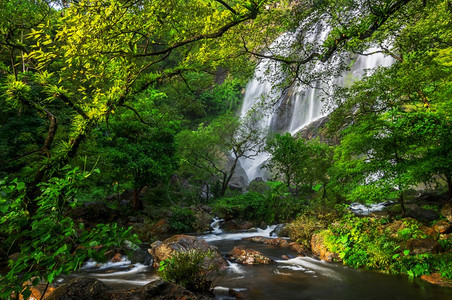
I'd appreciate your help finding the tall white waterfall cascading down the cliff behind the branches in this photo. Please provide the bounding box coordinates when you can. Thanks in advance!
[240,28,393,181]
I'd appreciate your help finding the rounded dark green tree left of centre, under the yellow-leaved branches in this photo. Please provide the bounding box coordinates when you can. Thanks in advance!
[98,99,178,210]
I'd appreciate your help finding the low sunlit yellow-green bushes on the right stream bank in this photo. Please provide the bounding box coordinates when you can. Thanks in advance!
[324,215,452,278]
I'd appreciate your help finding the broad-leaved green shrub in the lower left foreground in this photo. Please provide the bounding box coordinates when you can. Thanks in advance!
[0,168,136,298]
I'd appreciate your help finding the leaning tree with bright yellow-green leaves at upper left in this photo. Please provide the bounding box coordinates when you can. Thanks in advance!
[2,0,292,211]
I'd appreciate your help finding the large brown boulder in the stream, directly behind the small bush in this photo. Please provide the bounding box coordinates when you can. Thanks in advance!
[148,234,228,269]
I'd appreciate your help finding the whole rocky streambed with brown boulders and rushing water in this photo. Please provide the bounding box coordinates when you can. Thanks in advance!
[46,220,452,300]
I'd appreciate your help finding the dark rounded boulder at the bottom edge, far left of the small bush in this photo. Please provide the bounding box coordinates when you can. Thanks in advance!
[47,277,111,300]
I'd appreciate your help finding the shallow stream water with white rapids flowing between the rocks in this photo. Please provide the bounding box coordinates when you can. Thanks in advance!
[58,220,452,300]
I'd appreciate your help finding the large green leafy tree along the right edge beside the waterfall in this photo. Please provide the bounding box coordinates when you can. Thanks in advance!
[330,1,452,210]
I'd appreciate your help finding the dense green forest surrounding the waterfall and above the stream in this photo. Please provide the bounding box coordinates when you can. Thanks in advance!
[0,0,452,297]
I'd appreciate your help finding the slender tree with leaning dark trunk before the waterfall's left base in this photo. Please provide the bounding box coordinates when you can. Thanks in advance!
[178,116,265,196]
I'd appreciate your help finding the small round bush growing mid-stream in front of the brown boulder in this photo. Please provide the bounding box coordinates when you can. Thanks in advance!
[158,250,218,292]
